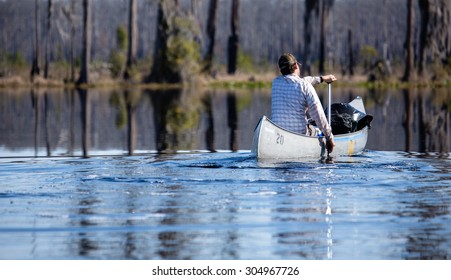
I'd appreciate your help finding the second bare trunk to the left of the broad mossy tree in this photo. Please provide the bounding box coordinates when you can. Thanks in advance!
[78,0,91,84]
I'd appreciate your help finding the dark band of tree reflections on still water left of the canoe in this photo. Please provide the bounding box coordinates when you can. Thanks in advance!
[0,89,266,157]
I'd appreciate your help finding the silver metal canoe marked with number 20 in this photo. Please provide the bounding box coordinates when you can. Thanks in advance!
[252,97,368,160]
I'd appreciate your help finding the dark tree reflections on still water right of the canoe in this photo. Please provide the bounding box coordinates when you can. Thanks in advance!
[364,88,451,155]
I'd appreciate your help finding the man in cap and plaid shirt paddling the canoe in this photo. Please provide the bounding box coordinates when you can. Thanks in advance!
[271,53,337,153]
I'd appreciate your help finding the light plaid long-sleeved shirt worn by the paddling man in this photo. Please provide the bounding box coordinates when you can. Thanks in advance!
[271,74,333,139]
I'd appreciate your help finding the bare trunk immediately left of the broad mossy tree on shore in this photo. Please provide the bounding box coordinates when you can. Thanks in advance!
[124,0,138,79]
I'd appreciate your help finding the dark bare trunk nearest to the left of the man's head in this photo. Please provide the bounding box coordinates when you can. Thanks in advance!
[227,0,240,74]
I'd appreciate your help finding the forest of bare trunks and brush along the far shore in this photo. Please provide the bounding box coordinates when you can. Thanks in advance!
[0,0,451,87]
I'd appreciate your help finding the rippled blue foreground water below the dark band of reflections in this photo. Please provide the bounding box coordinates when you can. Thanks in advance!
[0,151,451,259]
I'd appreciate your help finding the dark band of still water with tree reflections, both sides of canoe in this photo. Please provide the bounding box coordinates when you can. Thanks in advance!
[0,88,451,157]
